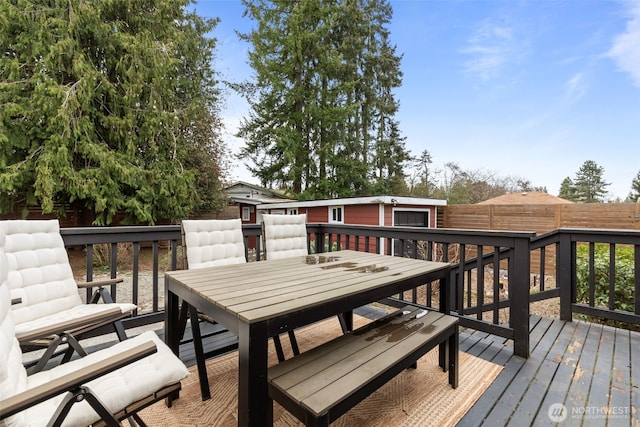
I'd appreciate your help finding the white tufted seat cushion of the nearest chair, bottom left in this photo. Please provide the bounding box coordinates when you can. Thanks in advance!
[25,331,189,426]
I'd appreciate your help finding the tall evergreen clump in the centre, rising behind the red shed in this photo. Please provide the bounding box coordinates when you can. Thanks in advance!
[238,0,408,199]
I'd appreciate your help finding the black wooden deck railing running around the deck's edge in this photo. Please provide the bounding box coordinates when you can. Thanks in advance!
[61,224,640,357]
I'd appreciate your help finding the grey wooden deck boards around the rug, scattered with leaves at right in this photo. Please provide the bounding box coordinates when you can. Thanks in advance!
[72,306,640,427]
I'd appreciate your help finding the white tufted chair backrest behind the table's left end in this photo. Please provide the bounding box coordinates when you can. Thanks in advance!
[182,219,247,269]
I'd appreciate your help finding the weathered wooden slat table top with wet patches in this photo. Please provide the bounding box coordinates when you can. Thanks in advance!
[167,250,449,323]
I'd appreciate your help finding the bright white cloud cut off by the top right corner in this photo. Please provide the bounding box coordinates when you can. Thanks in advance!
[609,2,640,87]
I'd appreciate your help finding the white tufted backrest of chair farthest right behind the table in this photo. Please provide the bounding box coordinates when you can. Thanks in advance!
[262,214,309,259]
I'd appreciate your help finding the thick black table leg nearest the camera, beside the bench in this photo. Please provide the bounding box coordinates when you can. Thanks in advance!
[238,323,273,427]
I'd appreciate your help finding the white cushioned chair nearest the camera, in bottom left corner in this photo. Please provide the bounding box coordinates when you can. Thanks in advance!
[0,222,189,427]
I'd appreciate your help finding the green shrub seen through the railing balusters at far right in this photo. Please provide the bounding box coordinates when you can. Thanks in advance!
[576,243,635,326]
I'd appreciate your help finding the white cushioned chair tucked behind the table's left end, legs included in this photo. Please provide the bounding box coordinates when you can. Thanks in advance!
[181,219,297,400]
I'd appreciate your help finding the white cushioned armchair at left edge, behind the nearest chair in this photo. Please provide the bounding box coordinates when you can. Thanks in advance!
[0,220,136,372]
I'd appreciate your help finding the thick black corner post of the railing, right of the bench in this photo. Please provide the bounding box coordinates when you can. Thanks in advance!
[509,238,531,358]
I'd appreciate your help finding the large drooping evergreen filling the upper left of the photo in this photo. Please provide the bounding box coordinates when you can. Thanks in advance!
[0,0,224,224]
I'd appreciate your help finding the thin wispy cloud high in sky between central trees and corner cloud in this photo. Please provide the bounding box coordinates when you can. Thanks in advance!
[461,19,527,81]
